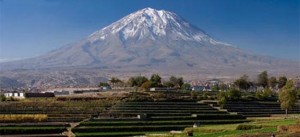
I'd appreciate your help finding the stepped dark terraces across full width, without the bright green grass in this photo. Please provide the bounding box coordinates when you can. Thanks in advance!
[0,93,300,137]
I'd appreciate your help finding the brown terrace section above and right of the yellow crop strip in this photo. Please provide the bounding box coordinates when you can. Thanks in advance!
[0,101,110,122]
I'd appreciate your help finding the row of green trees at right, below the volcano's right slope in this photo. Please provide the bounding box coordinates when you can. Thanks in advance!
[218,71,300,115]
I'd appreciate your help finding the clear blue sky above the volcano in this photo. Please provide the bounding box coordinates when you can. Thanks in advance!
[0,0,300,61]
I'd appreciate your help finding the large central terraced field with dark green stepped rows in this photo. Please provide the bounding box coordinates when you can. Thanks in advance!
[72,102,248,137]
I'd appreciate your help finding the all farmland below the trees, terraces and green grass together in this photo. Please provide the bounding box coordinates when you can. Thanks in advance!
[0,92,300,137]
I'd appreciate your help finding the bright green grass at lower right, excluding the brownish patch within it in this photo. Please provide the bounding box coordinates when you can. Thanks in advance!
[145,115,300,137]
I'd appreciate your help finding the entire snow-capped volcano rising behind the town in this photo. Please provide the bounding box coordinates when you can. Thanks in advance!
[0,8,300,88]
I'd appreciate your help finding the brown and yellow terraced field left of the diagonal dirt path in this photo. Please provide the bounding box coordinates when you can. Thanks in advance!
[0,99,110,137]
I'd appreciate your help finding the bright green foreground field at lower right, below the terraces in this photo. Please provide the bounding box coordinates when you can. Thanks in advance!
[148,114,300,137]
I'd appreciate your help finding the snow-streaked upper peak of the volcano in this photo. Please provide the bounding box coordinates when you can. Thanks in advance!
[89,8,231,45]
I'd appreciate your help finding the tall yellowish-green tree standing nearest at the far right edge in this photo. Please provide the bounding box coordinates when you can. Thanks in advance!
[279,80,297,117]
